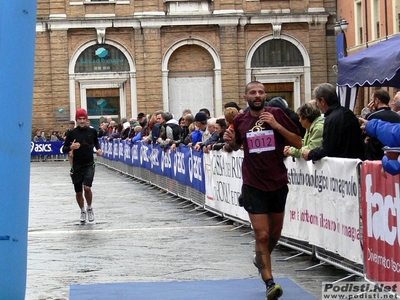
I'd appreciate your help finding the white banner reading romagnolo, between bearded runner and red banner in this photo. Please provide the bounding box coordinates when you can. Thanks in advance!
[282,158,363,264]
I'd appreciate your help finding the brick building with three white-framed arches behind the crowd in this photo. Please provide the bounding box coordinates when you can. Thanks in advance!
[33,0,336,131]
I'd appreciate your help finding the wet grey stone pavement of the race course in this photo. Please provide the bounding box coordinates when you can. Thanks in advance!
[26,161,348,300]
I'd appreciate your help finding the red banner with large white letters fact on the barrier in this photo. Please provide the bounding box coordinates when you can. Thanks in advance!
[361,161,400,282]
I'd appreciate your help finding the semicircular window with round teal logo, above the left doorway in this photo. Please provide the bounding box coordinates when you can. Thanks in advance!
[75,45,129,73]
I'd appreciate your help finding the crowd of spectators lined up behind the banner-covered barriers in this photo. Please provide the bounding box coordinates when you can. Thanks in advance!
[33,83,400,173]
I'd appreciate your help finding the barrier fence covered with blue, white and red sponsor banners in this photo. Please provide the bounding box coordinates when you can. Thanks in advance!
[31,140,400,283]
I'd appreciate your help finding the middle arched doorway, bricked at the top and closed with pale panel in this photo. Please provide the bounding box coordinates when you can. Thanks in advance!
[162,39,222,118]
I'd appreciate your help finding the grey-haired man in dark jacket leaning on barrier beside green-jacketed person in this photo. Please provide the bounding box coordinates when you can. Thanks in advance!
[302,83,364,161]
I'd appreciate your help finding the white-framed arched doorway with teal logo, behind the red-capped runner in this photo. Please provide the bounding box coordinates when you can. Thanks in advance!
[69,41,137,126]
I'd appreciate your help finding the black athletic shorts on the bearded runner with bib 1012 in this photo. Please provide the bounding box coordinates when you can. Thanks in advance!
[241,184,289,214]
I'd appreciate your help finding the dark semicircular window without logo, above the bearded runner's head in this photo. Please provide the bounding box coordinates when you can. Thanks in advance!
[251,39,304,68]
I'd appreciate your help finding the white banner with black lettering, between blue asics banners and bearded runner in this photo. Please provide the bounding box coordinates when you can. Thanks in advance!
[203,151,250,222]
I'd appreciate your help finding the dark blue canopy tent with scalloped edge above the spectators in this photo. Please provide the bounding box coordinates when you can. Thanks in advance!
[338,34,400,88]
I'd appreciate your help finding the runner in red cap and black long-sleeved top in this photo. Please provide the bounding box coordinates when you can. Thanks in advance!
[62,109,103,223]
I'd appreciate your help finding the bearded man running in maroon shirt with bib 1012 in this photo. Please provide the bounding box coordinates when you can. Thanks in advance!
[224,81,301,300]
